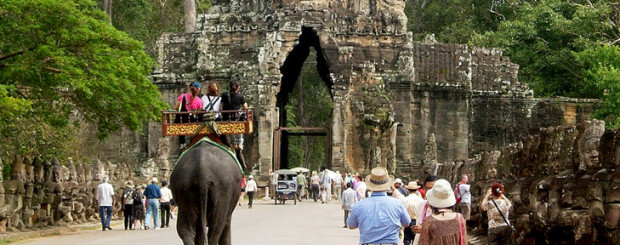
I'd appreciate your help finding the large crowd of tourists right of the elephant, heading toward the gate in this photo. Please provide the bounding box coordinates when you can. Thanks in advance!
[247,167,512,245]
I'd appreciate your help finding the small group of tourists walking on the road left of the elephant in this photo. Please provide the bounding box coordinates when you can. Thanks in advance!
[97,177,177,231]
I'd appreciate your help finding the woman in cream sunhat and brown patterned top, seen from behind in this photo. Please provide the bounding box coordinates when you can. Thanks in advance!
[419,179,467,245]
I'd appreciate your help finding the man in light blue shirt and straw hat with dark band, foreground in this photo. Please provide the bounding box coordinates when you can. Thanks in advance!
[347,167,411,245]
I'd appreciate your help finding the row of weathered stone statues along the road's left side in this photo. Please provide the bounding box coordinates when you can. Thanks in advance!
[0,156,153,232]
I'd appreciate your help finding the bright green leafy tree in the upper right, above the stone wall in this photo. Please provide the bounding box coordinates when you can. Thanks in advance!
[472,0,620,98]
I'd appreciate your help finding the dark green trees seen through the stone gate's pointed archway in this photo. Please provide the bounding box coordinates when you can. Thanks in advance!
[286,51,333,170]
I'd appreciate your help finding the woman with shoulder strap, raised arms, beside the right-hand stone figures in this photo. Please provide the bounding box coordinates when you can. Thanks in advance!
[480,182,512,244]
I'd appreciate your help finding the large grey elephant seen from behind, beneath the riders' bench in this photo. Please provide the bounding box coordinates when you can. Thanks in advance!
[170,141,242,245]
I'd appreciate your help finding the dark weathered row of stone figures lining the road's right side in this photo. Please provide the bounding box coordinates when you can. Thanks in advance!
[423,120,620,244]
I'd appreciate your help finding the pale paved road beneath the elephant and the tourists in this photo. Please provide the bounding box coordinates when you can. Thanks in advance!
[18,201,359,245]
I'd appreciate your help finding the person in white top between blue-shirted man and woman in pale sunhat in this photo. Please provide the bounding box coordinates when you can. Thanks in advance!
[392,181,425,245]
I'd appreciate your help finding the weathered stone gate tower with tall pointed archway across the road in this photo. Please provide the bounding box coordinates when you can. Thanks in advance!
[152,0,596,175]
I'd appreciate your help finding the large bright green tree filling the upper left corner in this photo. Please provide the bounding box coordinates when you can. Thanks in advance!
[0,0,166,156]
